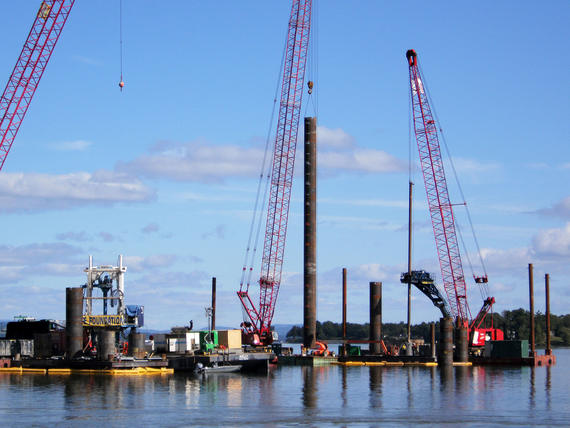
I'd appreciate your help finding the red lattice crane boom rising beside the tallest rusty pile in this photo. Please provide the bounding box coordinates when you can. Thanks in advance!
[237,0,312,344]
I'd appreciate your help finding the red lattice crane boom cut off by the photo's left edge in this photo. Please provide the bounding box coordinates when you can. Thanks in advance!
[0,0,75,170]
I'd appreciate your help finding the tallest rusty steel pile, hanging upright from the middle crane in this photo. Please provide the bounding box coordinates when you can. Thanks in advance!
[303,117,317,348]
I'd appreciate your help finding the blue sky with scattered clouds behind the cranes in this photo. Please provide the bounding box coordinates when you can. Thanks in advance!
[0,0,570,329]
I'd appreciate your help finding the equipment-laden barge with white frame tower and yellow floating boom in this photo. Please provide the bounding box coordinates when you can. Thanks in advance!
[0,256,275,375]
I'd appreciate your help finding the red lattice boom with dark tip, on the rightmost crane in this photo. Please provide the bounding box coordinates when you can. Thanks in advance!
[406,49,471,326]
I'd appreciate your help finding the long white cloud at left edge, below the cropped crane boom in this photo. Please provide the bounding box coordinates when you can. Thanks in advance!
[0,170,154,212]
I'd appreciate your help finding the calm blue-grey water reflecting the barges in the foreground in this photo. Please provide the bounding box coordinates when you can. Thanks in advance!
[0,349,570,427]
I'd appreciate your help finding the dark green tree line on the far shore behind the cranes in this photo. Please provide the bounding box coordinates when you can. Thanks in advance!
[287,308,570,346]
